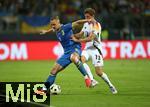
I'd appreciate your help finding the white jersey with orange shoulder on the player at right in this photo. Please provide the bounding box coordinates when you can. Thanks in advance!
[81,22,101,49]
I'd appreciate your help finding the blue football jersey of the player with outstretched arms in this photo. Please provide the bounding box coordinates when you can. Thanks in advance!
[56,23,81,53]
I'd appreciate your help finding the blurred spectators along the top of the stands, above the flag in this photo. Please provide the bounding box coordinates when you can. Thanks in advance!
[0,0,150,17]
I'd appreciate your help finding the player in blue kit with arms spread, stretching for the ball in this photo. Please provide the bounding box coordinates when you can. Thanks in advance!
[37,16,91,94]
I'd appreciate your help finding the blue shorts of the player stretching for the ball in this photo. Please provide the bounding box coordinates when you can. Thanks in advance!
[56,48,81,68]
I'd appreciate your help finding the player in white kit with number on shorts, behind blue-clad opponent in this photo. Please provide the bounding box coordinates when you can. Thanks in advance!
[72,8,117,94]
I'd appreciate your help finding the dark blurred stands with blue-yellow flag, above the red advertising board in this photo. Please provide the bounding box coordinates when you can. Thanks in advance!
[0,0,150,40]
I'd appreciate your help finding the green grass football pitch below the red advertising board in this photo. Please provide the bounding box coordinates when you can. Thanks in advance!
[0,60,150,107]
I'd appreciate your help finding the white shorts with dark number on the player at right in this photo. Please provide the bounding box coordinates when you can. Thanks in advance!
[81,49,104,67]
